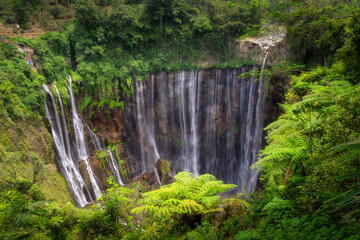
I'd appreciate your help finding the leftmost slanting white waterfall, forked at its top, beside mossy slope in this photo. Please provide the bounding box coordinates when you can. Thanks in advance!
[43,85,93,207]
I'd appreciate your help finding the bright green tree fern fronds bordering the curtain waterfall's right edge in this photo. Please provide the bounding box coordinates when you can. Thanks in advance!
[253,81,333,187]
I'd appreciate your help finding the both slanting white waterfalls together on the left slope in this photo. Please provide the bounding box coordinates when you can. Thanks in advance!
[43,76,107,207]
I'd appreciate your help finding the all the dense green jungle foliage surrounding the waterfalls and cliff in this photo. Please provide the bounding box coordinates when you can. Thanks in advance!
[0,0,360,240]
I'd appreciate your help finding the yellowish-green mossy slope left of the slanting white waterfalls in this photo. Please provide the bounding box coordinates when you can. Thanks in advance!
[0,118,73,205]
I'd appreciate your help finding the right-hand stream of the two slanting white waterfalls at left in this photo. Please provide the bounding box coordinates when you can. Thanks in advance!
[69,75,101,198]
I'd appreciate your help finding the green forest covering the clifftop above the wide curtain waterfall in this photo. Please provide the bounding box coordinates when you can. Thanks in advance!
[0,0,269,117]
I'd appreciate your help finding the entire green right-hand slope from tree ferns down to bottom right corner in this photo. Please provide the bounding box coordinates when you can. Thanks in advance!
[243,64,360,239]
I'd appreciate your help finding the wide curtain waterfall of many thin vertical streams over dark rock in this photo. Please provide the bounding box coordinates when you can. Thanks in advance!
[127,64,265,192]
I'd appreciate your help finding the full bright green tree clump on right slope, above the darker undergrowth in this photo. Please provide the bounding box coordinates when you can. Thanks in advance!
[255,66,357,191]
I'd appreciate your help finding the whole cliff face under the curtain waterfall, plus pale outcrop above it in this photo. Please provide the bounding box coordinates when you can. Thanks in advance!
[86,26,287,191]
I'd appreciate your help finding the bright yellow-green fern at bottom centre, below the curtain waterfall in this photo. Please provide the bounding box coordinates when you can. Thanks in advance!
[132,172,236,218]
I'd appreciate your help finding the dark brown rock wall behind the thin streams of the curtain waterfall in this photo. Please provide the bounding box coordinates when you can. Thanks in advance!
[88,67,286,193]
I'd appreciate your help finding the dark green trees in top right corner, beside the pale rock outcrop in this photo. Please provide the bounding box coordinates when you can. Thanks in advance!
[272,0,360,83]
